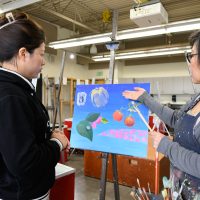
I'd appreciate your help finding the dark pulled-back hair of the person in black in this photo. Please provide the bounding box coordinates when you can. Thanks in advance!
[0,13,45,62]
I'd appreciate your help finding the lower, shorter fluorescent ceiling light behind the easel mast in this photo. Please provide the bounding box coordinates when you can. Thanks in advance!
[92,46,191,62]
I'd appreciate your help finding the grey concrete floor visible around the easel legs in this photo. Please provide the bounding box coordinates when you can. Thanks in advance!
[66,153,132,200]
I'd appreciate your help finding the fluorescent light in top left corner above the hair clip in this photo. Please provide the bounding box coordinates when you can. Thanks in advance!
[0,0,41,14]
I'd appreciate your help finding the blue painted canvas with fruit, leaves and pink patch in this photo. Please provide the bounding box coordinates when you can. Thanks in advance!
[70,83,150,158]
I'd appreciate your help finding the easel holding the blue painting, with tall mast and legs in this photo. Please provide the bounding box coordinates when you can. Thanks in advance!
[99,11,120,200]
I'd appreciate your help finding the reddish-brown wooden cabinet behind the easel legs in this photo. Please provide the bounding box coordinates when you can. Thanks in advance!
[84,137,169,192]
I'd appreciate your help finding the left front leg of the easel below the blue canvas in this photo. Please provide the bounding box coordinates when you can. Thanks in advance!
[99,153,108,200]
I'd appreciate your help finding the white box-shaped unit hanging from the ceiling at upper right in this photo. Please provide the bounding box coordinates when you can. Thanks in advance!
[130,1,168,27]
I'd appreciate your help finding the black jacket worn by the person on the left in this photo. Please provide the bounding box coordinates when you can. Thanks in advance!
[0,68,60,200]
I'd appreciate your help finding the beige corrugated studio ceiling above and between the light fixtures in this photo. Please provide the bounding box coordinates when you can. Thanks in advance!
[1,0,200,64]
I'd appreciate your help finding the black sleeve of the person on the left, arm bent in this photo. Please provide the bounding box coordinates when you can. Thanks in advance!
[0,96,60,177]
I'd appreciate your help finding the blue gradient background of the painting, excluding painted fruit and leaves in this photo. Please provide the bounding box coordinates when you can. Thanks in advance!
[70,83,150,157]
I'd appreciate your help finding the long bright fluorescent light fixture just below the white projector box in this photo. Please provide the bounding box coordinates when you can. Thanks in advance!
[49,18,200,49]
